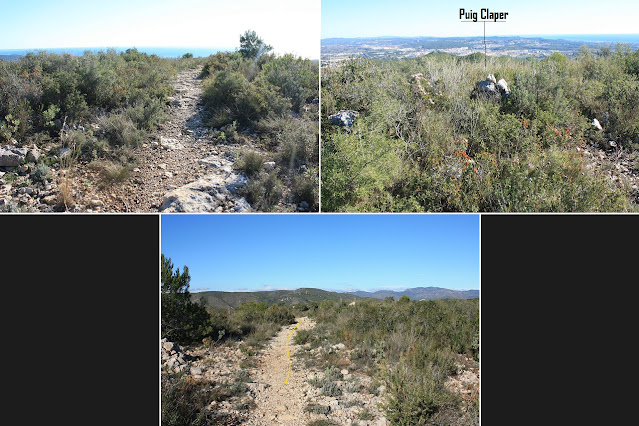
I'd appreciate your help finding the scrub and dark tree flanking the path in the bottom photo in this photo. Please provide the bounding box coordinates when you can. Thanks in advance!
[162,257,479,425]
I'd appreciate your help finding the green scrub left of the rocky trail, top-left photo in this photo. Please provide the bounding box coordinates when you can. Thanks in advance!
[0,49,181,210]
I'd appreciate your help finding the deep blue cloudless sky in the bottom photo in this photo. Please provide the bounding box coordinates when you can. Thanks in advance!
[161,214,479,292]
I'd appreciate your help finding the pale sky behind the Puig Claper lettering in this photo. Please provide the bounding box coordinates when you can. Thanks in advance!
[322,0,639,38]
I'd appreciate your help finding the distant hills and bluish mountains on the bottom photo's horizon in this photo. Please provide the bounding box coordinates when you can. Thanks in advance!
[191,287,479,309]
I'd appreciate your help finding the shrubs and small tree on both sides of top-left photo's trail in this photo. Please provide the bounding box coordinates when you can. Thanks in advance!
[0,31,319,211]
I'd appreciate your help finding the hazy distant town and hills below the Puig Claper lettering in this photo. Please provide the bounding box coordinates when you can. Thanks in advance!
[321,36,639,65]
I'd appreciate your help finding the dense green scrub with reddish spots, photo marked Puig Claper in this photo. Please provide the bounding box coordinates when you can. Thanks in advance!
[322,45,639,211]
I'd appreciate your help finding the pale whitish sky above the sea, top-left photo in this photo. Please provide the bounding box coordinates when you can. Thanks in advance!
[0,0,320,59]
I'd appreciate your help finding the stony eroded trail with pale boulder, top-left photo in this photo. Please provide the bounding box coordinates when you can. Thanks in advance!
[97,68,252,212]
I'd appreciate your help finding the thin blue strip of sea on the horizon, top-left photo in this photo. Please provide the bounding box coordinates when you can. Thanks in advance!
[0,46,235,58]
